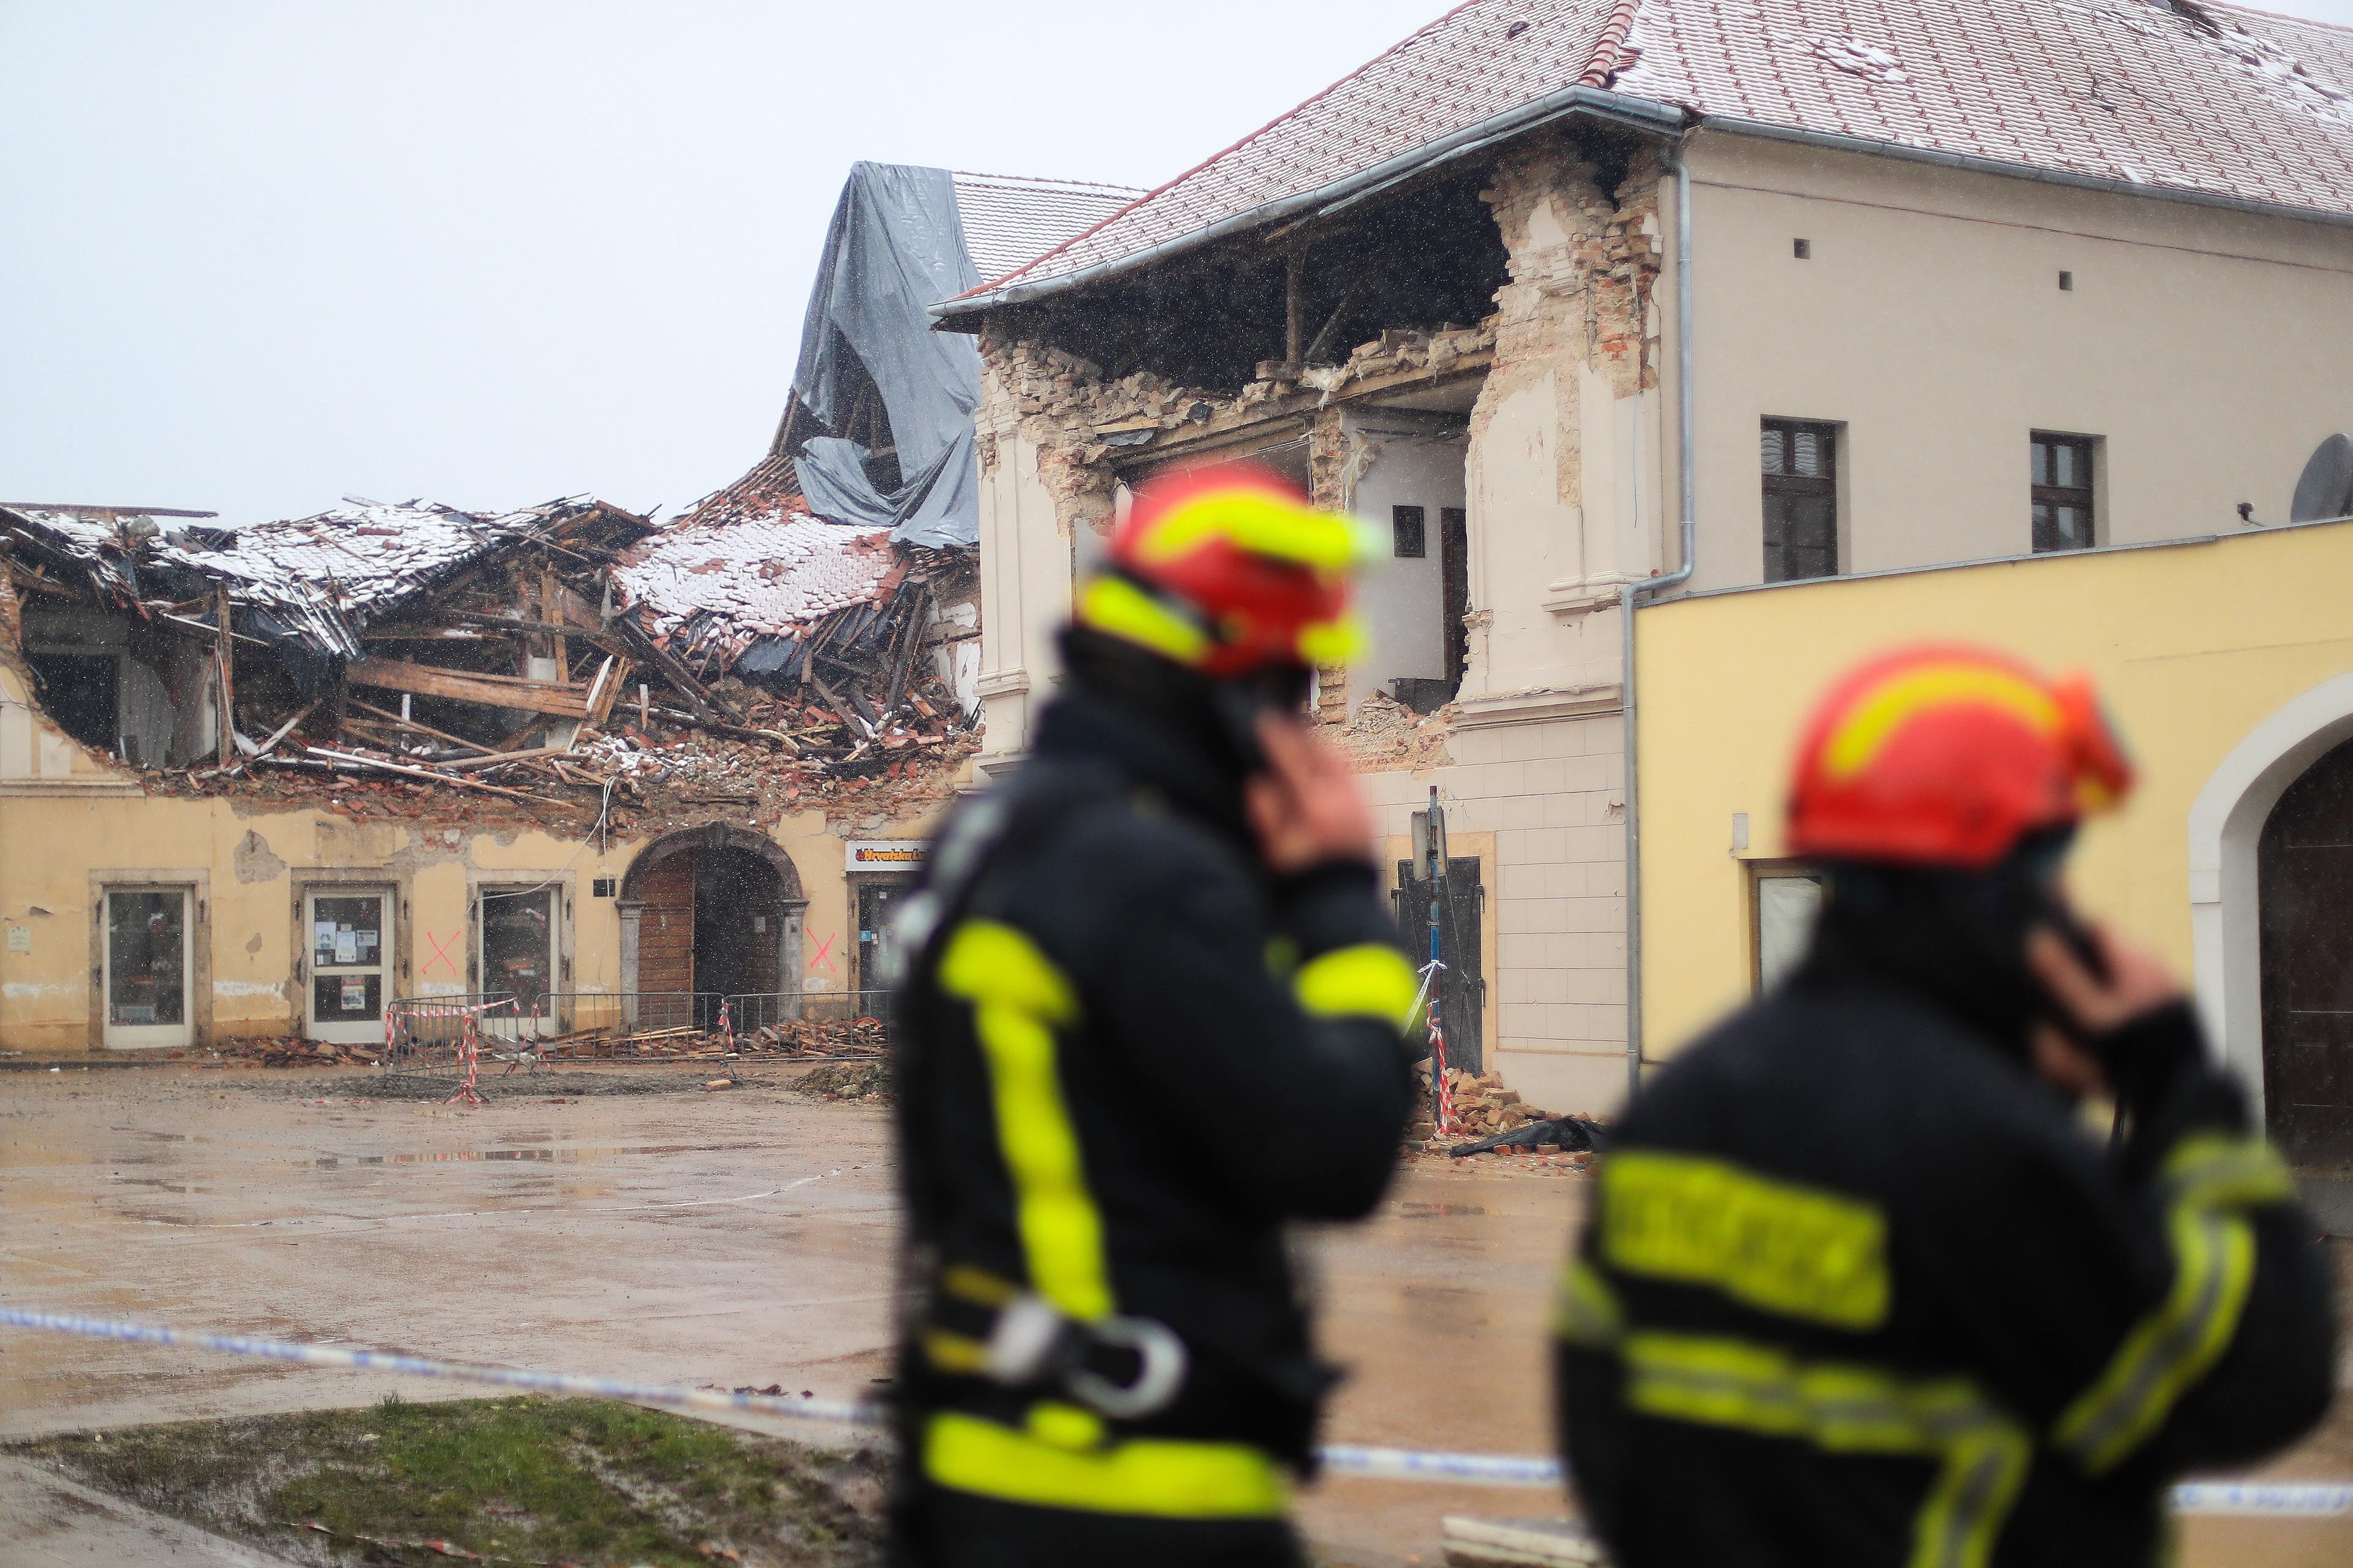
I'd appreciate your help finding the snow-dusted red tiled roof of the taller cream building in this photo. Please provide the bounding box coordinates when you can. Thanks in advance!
[934,0,2353,322]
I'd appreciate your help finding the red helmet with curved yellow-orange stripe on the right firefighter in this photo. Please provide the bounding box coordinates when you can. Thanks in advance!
[1788,645,2132,869]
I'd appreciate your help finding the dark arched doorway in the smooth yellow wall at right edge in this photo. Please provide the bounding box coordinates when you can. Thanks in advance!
[2257,741,2353,1165]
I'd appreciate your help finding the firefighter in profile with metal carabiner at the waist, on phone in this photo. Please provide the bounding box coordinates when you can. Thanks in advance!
[892,469,1417,1568]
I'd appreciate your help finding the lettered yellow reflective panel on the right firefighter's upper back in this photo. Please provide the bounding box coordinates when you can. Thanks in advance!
[1602,1149,1890,1328]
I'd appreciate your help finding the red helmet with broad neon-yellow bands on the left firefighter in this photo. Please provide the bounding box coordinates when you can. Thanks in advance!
[1073,464,1367,678]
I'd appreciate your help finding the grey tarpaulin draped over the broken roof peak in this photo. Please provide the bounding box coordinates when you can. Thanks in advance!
[793,162,981,546]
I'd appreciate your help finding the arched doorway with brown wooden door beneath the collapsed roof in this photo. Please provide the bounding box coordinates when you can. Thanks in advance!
[619,822,807,1029]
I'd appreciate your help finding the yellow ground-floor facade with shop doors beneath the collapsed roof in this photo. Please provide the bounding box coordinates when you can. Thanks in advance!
[0,645,922,1057]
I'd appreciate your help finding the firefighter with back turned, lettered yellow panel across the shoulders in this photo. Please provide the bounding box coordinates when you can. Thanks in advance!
[1558,648,2334,1568]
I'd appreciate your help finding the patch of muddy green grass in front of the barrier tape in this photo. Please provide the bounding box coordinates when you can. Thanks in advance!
[17,1398,882,1568]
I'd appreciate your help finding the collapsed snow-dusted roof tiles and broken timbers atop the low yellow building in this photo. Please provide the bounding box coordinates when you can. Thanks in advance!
[0,464,979,831]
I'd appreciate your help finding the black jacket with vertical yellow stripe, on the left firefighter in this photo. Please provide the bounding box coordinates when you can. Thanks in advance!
[896,692,1414,1521]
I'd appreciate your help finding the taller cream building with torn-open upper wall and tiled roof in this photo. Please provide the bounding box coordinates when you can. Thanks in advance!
[934,0,2353,1112]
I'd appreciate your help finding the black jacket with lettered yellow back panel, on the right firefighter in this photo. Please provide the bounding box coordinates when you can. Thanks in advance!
[1560,927,2334,1568]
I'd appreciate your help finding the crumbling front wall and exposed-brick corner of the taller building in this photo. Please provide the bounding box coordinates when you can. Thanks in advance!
[981,137,1669,1112]
